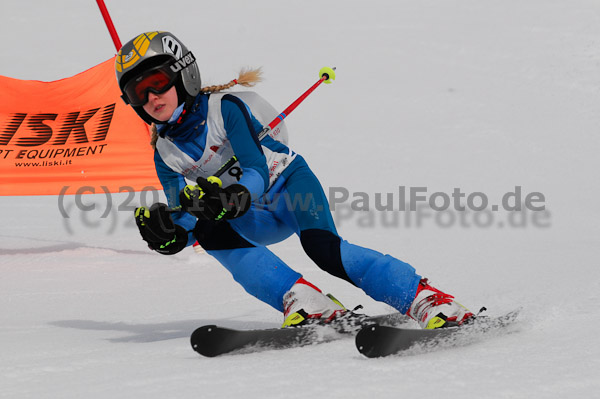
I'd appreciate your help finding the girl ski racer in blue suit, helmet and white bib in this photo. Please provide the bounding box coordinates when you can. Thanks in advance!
[116,32,474,328]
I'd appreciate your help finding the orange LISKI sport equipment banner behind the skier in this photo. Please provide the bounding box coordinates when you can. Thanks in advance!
[0,58,161,195]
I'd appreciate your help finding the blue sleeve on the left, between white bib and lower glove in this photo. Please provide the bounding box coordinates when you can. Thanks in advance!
[154,151,196,245]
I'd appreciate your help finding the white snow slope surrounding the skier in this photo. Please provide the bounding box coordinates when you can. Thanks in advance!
[0,0,600,398]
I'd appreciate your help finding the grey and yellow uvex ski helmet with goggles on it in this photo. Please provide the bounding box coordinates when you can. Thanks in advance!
[115,31,201,123]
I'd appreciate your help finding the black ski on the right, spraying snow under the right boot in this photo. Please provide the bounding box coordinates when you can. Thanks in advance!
[355,310,520,358]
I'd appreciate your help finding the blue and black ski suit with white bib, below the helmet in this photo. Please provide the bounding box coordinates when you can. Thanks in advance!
[154,92,421,313]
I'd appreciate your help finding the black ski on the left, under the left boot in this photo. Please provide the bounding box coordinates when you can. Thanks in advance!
[190,313,412,357]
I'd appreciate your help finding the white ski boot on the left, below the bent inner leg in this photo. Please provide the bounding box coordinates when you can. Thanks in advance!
[282,278,346,328]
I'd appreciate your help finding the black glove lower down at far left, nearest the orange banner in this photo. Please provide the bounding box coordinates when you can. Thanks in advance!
[135,202,188,255]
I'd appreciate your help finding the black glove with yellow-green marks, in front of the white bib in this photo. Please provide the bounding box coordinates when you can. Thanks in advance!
[179,176,252,221]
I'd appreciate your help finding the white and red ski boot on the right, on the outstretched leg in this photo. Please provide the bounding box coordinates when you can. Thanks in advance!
[406,278,475,329]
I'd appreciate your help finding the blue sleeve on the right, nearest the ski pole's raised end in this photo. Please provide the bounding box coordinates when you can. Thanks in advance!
[221,94,269,199]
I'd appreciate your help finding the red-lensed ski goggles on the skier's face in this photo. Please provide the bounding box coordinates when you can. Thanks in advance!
[121,62,178,107]
